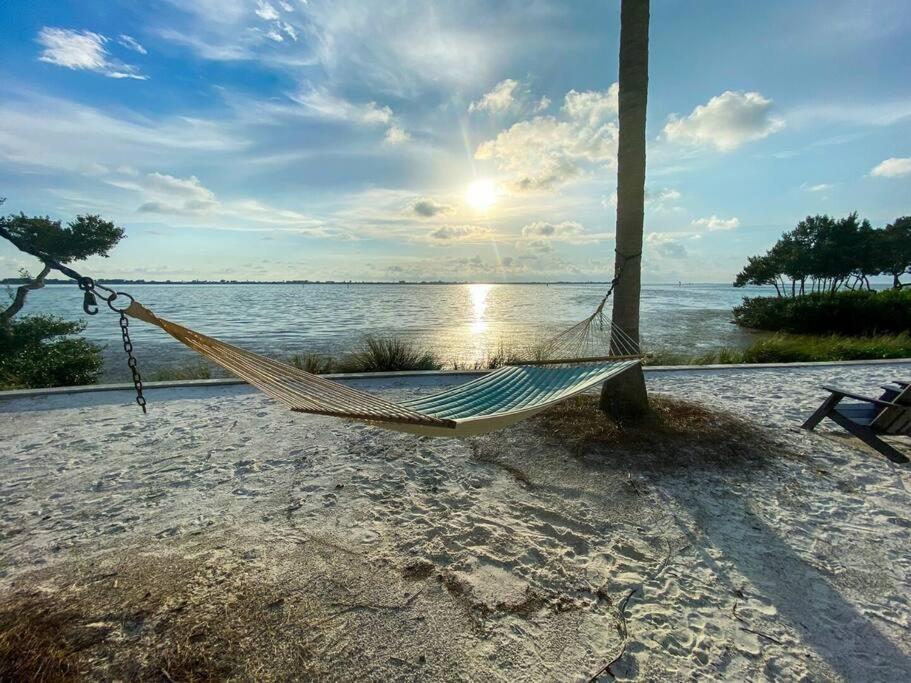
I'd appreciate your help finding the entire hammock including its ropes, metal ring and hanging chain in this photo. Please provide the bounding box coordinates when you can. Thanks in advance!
[0,227,641,436]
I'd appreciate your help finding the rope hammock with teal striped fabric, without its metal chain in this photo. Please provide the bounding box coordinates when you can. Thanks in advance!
[123,297,639,437]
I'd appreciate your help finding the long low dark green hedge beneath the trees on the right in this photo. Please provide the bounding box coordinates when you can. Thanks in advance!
[734,289,911,335]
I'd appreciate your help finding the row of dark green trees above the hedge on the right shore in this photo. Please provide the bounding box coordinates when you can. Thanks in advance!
[734,212,911,297]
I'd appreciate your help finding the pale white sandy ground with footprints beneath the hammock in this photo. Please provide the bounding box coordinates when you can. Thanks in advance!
[0,364,911,681]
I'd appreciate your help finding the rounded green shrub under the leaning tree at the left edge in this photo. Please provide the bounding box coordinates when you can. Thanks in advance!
[0,315,101,389]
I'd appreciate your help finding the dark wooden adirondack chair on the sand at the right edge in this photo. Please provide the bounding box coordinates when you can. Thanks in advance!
[802,381,911,463]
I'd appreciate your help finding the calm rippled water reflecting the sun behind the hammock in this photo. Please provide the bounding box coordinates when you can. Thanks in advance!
[25,284,767,380]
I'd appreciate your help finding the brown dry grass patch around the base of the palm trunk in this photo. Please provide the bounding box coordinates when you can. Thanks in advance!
[539,394,768,463]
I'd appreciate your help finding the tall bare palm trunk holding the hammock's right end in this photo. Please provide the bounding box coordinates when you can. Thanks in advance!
[601,0,649,418]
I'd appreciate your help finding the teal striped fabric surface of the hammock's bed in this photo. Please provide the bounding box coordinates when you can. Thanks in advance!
[401,361,638,420]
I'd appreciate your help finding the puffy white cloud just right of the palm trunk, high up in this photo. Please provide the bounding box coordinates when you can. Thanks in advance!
[664,90,784,152]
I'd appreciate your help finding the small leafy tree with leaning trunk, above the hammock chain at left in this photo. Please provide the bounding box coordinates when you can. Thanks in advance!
[0,207,123,327]
